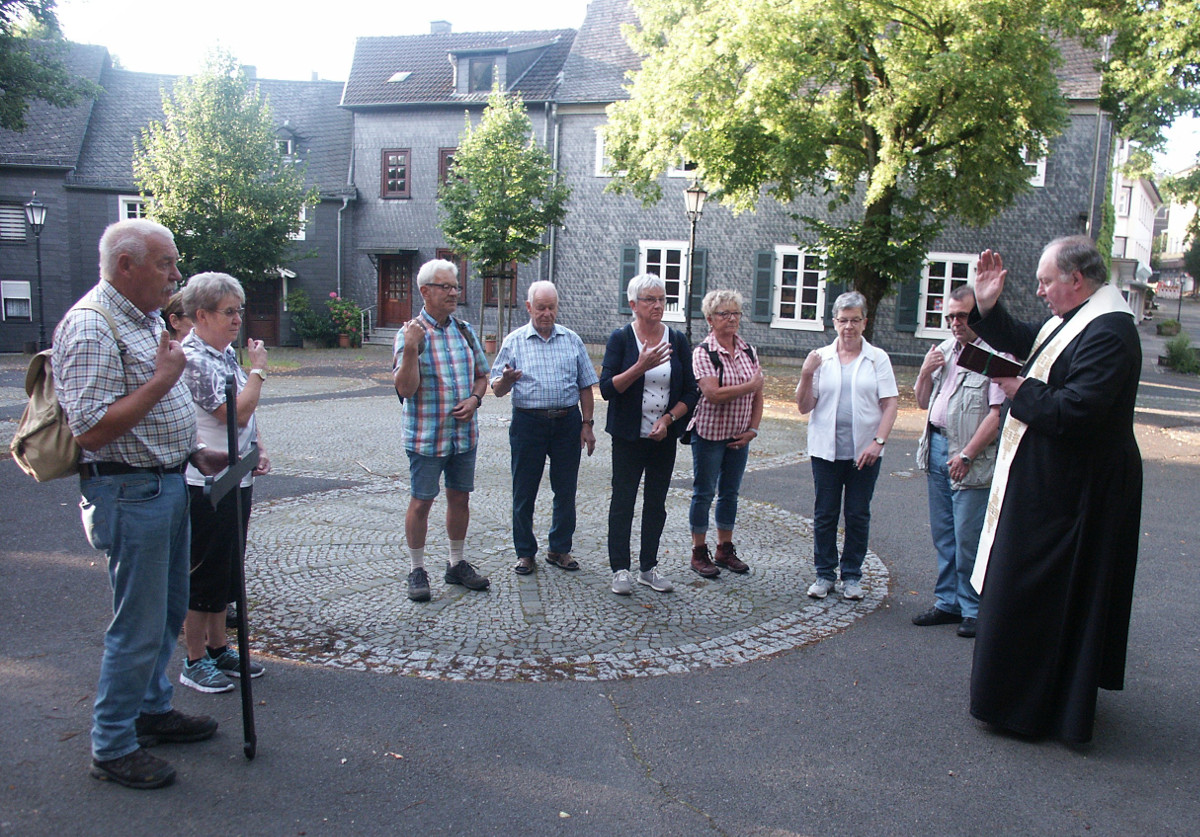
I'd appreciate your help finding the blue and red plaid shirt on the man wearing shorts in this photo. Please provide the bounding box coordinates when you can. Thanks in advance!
[392,308,487,457]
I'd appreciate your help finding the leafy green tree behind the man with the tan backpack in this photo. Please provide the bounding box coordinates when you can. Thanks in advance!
[133,50,318,282]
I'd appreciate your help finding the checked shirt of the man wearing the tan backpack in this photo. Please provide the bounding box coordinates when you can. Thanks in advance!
[53,281,196,468]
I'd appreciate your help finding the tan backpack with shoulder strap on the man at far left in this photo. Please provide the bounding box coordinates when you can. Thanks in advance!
[8,302,121,482]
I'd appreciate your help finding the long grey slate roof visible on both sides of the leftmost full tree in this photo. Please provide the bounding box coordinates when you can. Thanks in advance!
[67,68,354,197]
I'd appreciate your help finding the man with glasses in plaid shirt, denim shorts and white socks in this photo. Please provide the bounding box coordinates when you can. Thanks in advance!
[392,259,490,602]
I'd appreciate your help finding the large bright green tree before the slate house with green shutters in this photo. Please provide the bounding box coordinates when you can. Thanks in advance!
[605,0,1066,335]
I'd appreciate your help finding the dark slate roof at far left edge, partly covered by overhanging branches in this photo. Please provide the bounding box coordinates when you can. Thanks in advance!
[0,43,110,168]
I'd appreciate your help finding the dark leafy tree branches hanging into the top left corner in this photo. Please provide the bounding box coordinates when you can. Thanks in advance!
[0,0,100,131]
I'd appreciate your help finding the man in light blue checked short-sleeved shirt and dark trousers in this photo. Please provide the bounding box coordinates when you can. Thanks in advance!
[492,282,600,576]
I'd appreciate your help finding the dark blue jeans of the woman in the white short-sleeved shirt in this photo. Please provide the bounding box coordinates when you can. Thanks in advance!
[812,457,883,582]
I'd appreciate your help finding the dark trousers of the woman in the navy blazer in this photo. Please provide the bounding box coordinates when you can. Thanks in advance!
[608,435,679,572]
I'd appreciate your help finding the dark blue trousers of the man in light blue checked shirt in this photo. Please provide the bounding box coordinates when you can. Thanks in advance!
[509,407,583,558]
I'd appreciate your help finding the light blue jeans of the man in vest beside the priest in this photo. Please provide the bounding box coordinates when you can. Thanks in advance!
[929,433,989,619]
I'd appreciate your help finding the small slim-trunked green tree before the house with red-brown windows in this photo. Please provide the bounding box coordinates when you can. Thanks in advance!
[438,88,571,337]
